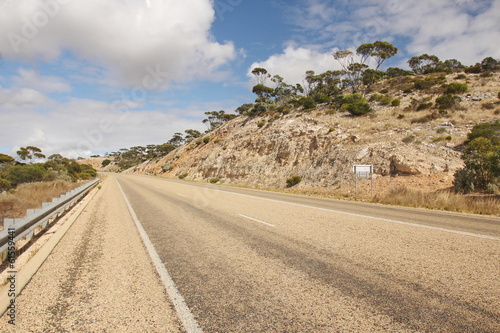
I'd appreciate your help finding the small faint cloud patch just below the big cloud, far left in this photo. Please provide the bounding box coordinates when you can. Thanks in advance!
[13,68,71,93]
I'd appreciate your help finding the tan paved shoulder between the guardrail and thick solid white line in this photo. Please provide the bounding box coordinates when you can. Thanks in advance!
[0,177,182,332]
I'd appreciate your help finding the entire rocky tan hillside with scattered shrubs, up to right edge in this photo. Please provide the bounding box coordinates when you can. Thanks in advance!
[126,73,500,193]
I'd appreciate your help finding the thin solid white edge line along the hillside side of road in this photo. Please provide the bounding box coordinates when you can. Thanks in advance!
[165,180,500,241]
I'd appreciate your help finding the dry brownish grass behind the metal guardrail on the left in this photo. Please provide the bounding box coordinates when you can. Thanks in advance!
[0,180,81,223]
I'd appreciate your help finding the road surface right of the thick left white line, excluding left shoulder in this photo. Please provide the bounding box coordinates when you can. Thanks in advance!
[115,175,500,332]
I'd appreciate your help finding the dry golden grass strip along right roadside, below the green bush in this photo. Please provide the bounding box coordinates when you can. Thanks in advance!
[374,186,500,215]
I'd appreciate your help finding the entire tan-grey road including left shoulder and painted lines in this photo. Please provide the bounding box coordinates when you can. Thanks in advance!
[0,174,500,332]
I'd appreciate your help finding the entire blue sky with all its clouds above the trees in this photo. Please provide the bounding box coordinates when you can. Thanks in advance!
[0,0,500,158]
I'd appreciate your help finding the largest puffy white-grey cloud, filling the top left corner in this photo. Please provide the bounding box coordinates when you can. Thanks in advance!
[0,0,236,86]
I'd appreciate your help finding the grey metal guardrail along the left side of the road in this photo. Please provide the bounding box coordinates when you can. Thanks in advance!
[0,178,99,262]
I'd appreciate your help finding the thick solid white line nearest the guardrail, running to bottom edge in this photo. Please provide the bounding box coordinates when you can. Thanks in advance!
[116,180,203,333]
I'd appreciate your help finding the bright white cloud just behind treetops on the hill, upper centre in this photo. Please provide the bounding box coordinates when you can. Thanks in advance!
[247,46,339,85]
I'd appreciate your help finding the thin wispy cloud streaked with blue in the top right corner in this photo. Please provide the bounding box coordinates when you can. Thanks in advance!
[284,0,500,65]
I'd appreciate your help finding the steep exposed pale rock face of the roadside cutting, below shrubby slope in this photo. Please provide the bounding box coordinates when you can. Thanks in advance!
[128,114,462,187]
